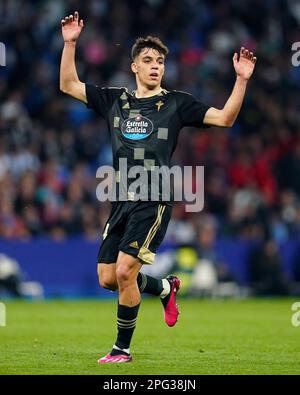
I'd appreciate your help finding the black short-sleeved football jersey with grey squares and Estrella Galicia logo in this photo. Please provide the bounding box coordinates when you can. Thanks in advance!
[86,84,209,204]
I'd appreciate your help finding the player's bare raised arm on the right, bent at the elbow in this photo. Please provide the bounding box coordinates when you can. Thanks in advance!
[203,47,256,127]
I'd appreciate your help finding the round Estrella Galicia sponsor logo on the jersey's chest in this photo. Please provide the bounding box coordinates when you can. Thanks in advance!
[121,115,153,140]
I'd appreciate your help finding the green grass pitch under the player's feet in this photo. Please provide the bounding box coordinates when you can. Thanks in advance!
[0,298,300,375]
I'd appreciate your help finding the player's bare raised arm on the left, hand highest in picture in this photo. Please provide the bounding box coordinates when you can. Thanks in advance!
[60,11,87,103]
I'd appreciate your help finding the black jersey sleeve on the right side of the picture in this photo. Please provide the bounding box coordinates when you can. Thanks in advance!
[175,92,211,128]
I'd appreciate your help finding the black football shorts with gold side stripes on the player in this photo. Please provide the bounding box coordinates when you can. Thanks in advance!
[98,201,172,264]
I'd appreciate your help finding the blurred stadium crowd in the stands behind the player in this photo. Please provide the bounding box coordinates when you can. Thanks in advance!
[0,0,300,251]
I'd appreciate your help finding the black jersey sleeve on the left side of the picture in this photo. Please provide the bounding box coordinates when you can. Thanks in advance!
[85,84,124,118]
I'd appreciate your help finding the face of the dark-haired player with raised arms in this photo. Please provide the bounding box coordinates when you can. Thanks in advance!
[131,48,165,89]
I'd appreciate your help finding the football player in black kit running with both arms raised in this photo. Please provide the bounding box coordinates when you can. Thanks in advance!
[60,12,256,363]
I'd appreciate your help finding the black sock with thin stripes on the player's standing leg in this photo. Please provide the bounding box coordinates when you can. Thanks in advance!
[110,303,140,355]
